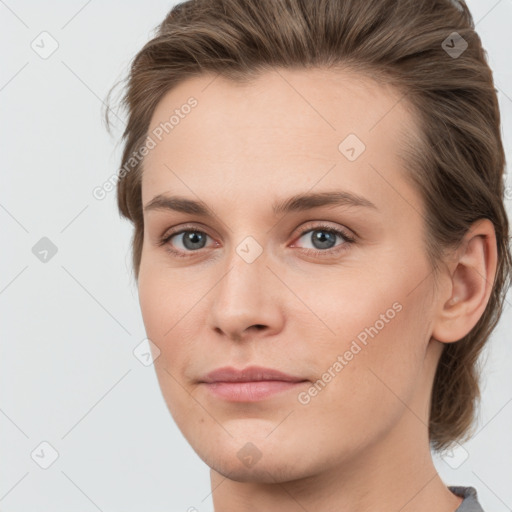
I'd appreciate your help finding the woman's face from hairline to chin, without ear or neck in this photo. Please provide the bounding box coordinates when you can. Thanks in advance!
[138,70,439,482]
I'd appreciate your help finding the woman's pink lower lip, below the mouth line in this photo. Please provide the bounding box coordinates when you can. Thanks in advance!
[204,380,306,402]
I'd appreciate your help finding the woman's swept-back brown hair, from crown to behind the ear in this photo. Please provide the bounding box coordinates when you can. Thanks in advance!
[106,0,511,451]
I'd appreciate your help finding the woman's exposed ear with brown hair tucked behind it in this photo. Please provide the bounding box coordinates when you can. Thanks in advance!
[432,219,498,343]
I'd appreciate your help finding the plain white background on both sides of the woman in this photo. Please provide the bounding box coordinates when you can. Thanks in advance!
[0,0,512,512]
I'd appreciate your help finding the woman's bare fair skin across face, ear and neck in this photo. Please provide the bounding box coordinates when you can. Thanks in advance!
[138,69,496,512]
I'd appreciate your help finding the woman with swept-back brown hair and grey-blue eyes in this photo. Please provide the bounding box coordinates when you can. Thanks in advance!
[106,0,511,512]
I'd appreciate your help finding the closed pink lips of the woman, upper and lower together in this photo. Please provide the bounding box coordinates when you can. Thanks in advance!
[199,366,308,402]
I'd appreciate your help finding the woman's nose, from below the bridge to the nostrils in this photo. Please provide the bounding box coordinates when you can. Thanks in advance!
[209,247,283,341]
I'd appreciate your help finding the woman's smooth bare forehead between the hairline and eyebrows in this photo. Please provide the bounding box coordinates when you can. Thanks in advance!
[142,69,416,212]
